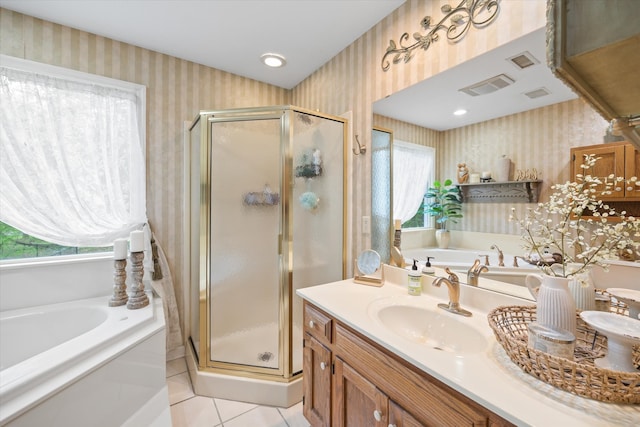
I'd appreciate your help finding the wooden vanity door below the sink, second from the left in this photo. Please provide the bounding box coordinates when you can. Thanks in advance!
[333,357,389,427]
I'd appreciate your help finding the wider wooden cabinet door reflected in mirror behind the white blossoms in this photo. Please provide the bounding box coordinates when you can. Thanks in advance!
[571,144,625,200]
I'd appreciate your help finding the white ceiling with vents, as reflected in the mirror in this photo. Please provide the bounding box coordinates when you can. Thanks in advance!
[373,28,577,130]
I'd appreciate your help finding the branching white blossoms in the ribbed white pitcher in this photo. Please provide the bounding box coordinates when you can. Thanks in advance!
[509,155,640,277]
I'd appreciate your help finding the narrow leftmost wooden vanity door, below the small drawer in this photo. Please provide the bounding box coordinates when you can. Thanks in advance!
[302,334,331,427]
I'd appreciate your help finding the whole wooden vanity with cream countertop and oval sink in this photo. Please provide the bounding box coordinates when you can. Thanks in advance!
[297,266,640,427]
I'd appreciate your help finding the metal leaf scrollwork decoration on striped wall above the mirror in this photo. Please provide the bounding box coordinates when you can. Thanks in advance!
[381,0,500,71]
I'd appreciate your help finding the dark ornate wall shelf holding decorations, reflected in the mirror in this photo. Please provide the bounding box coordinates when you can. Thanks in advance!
[458,180,542,203]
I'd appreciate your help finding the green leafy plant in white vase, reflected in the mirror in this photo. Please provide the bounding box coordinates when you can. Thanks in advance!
[425,179,462,249]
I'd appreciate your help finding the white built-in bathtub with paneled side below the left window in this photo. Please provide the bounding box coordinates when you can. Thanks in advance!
[0,295,171,426]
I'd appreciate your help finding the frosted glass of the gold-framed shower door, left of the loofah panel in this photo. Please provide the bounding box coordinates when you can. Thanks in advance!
[210,118,282,368]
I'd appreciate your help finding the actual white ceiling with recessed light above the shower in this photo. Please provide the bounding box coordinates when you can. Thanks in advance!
[0,0,405,89]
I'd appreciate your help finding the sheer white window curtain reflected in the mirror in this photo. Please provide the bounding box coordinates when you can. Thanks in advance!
[393,140,435,223]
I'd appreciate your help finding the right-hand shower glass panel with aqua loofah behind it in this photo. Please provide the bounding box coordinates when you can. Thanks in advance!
[292,113,345,372]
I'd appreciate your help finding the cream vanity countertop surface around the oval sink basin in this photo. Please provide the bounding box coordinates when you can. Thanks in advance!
[297,272,640,427]
